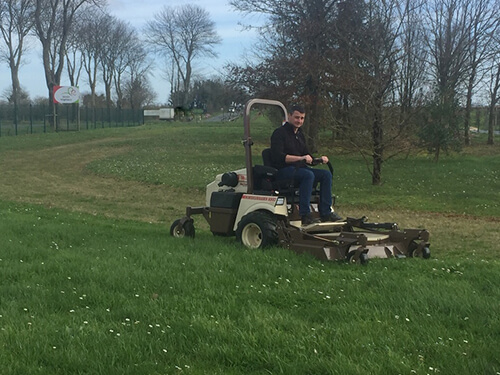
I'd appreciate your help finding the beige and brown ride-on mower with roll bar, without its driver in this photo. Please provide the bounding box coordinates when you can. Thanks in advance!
[170,99,430,264]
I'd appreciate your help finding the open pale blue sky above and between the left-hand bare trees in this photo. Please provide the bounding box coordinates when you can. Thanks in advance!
[0,0,264,103]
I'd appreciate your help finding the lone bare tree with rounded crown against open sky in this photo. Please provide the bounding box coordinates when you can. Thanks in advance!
[145,4,221,106]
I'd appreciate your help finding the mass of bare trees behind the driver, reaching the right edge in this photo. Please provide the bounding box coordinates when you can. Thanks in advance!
[230,0,500,184]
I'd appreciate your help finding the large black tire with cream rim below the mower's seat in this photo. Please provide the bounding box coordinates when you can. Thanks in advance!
[236,211,278,249]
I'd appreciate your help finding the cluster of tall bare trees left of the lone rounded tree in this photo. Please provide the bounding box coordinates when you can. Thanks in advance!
[0,0,152,119]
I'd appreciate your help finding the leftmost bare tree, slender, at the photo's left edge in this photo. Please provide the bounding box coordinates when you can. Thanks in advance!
[0,0,34,113]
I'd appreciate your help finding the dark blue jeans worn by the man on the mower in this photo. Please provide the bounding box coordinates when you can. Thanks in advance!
[276,166,332,216]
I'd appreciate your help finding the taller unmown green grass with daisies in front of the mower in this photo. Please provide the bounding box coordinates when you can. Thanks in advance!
[0,203,500,374]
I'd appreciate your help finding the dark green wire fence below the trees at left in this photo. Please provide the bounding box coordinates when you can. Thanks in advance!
[0,104,144,137]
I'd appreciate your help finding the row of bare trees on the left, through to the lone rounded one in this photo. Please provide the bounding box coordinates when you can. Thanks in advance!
[0,0,229,120]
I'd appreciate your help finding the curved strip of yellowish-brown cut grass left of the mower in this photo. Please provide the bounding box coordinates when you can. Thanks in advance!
[0,140,203,222]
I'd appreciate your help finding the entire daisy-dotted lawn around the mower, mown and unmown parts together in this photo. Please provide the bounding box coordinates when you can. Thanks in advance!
[0,120,500,375]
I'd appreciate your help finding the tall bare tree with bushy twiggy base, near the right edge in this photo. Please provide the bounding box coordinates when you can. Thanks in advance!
[422,0,472,161]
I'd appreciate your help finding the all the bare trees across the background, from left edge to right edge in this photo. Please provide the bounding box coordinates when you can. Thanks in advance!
[0,0,500,184]
